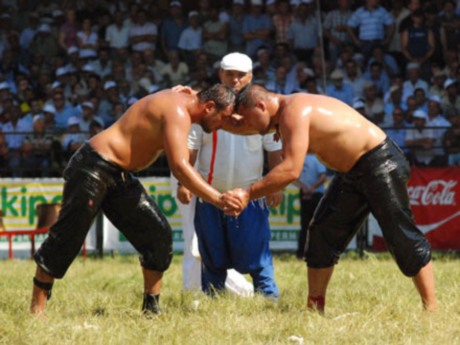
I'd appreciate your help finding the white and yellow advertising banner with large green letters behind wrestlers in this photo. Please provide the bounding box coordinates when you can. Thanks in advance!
[0,177,300,257]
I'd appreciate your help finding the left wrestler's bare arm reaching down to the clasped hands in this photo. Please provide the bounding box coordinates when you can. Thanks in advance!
[163,109,222,207]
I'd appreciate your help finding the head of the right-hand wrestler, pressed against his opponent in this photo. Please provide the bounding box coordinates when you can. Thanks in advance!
[232,84,275,134]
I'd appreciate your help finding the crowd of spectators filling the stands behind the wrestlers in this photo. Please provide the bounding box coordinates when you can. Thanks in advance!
[0,0,460,177]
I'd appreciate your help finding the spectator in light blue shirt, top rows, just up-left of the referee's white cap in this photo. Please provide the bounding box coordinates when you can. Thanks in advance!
[177,11,203,66]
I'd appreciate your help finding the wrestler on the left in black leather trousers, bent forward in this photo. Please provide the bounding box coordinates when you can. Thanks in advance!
[30,84,241,314]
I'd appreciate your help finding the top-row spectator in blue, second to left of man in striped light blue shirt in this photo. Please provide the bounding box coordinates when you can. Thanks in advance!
[288,0,320,63]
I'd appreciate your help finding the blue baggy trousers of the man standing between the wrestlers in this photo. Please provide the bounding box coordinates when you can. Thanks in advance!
[195,199,279,298]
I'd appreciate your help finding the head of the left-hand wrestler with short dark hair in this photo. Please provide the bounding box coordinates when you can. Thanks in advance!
[197,84,236,133]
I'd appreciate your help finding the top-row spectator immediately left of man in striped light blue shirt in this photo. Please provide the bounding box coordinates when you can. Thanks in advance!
[323,0,352,62]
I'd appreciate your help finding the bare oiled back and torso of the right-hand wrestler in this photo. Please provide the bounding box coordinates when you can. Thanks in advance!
[278,94,386,172]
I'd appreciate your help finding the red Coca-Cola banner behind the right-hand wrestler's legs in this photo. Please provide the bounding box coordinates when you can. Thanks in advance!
[372,167,460,250]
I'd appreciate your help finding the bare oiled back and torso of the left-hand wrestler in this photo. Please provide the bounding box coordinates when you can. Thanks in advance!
[90,90,191,171]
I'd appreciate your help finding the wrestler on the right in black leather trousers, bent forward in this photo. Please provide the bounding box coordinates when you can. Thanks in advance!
[224,85,436,312]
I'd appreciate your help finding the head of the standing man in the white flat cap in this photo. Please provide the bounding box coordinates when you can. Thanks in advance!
[219,53,252,92]
